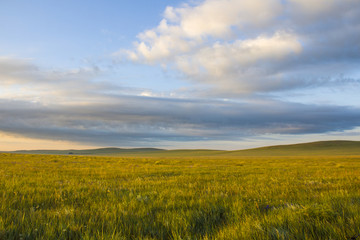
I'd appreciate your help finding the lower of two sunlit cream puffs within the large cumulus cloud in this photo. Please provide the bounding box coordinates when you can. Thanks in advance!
[176,32,302,87]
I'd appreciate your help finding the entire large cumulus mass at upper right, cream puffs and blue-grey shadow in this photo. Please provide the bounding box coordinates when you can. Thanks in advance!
[121,0,360,94]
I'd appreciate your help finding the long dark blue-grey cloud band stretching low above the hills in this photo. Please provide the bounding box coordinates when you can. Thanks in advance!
[0,96,360,146]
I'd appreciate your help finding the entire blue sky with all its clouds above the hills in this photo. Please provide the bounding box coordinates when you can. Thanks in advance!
[0,0,360,151]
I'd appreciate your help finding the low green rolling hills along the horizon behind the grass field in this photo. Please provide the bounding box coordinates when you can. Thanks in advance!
[7,141,360,157]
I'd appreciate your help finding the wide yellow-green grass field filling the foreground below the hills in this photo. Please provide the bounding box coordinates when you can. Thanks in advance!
[0,142,360,240]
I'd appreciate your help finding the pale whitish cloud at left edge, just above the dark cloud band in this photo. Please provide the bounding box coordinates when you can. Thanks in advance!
[0,56,125,104]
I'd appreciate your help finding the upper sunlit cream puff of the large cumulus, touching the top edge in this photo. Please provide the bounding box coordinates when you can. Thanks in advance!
[126,0,281,63]
